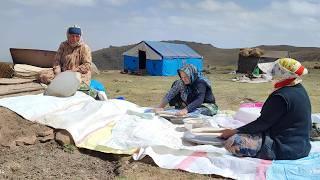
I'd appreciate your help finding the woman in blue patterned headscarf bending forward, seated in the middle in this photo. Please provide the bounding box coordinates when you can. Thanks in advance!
[156,64,218,116]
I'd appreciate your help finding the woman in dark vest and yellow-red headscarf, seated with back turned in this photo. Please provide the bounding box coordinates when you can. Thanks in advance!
[221,58,311,160]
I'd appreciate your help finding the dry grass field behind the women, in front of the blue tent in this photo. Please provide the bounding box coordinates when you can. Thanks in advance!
[95,66,320,113]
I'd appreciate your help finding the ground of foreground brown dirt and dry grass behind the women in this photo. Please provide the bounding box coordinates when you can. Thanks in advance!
[0,65,320,179]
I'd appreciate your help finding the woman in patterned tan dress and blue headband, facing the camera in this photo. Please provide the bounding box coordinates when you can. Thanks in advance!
[38,26,92,86]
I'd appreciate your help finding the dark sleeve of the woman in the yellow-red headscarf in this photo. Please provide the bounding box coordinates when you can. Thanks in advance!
[237,95,288,134]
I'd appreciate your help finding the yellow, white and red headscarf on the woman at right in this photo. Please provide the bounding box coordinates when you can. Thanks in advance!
[258,58,308,89]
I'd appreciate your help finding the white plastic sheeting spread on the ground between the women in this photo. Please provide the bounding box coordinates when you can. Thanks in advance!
[0,92,320,179]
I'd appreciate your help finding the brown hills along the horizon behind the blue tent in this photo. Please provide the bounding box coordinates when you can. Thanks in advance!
[92,40,320,70]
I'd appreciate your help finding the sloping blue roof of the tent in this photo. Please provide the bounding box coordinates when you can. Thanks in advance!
[144,41,202,58]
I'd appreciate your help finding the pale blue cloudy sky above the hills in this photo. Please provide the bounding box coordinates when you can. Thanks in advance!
[0,0,320,61]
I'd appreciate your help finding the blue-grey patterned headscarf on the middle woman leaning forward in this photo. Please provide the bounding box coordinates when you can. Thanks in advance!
[178,64,211,101]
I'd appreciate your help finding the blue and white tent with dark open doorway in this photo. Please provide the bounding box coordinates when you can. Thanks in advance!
[123,41,203,76]
